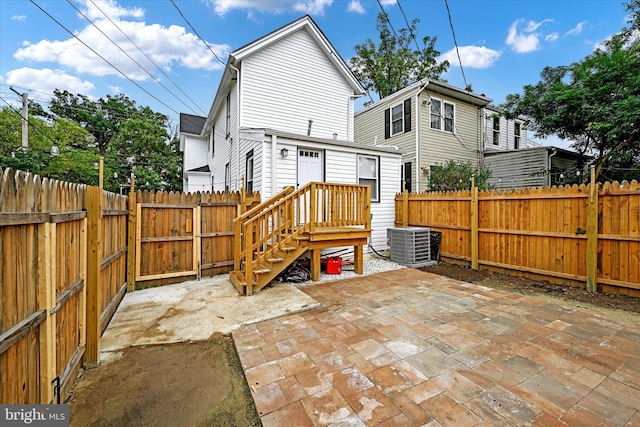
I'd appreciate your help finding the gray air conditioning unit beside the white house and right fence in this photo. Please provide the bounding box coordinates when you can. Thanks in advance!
[387,227,436,268]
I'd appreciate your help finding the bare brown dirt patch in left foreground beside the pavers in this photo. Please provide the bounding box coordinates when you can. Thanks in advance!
[67,335,261,427]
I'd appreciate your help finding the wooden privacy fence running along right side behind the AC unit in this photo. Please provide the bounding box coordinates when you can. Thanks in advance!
[395,171,640,297]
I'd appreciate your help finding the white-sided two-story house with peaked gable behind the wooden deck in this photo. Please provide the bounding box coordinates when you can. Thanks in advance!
[181,16,402,251]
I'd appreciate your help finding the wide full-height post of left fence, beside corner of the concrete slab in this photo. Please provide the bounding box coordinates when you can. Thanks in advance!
[85,186,102,368]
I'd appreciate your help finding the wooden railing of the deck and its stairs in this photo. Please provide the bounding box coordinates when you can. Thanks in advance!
[234,182,371,280]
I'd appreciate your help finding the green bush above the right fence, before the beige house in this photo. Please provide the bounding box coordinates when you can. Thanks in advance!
[422,160,491,191]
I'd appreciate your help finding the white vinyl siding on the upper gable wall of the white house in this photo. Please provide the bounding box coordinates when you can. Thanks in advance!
[241,29,353,140]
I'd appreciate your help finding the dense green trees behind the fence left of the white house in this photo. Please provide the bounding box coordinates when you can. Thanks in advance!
[0,90,182,192]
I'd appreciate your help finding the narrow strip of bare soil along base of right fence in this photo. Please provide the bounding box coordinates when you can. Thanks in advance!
[420,263,640,325]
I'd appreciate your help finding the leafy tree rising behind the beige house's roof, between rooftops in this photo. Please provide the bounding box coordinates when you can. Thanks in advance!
[351,12,449,98]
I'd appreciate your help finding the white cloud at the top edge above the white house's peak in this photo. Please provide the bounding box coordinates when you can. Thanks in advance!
[207,0,336,16]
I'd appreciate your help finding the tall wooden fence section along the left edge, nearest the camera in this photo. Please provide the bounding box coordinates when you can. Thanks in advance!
[0,169,127,403]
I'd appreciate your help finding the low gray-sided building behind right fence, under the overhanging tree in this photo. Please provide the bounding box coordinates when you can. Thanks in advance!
[484,146,586,189]
